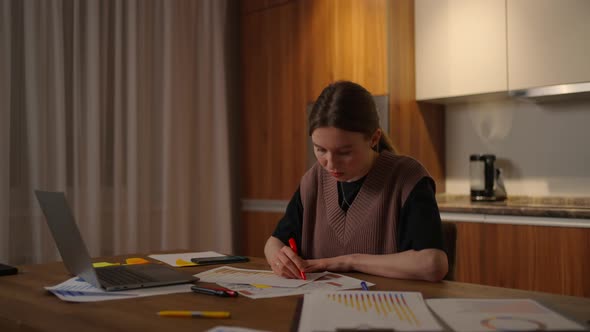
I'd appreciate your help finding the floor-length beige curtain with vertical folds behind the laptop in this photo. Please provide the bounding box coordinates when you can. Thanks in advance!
[0,0,237,264]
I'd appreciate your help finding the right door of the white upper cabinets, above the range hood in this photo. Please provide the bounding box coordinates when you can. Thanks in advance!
[507,0,590,90]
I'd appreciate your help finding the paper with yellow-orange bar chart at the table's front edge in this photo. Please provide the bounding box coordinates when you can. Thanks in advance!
[299,291,442,332]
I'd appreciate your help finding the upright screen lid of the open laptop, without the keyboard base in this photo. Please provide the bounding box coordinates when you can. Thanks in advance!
[35,190,101,288]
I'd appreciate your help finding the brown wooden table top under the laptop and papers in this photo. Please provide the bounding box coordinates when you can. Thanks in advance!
[0,256,590,332]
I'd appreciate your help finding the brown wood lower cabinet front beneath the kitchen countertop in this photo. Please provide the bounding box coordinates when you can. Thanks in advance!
[455,222,590,297]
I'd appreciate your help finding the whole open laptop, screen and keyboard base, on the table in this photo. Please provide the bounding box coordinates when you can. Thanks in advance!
[35,190,199,291]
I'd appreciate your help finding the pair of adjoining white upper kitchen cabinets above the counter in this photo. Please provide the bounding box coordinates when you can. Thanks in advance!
[415,0,590,100]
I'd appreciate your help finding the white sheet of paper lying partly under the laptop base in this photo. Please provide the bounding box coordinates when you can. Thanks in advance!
[45,277,193,302]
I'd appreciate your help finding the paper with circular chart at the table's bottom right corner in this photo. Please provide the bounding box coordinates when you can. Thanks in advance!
[426,299,584,332]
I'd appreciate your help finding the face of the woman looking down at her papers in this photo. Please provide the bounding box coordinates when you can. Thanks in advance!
[311,127,381,181]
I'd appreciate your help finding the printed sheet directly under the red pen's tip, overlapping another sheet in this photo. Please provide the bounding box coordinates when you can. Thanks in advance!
[195,266,322,287]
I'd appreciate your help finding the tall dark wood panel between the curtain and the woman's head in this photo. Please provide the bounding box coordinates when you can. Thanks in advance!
[241,1,306,200]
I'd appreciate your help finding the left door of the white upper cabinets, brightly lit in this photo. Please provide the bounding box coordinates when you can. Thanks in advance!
[415,0,508,100]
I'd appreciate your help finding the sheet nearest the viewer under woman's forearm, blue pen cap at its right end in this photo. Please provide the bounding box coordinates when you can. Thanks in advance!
[218,272,375,299]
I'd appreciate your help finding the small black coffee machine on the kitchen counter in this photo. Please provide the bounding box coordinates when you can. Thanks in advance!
[469,154,506,202]
